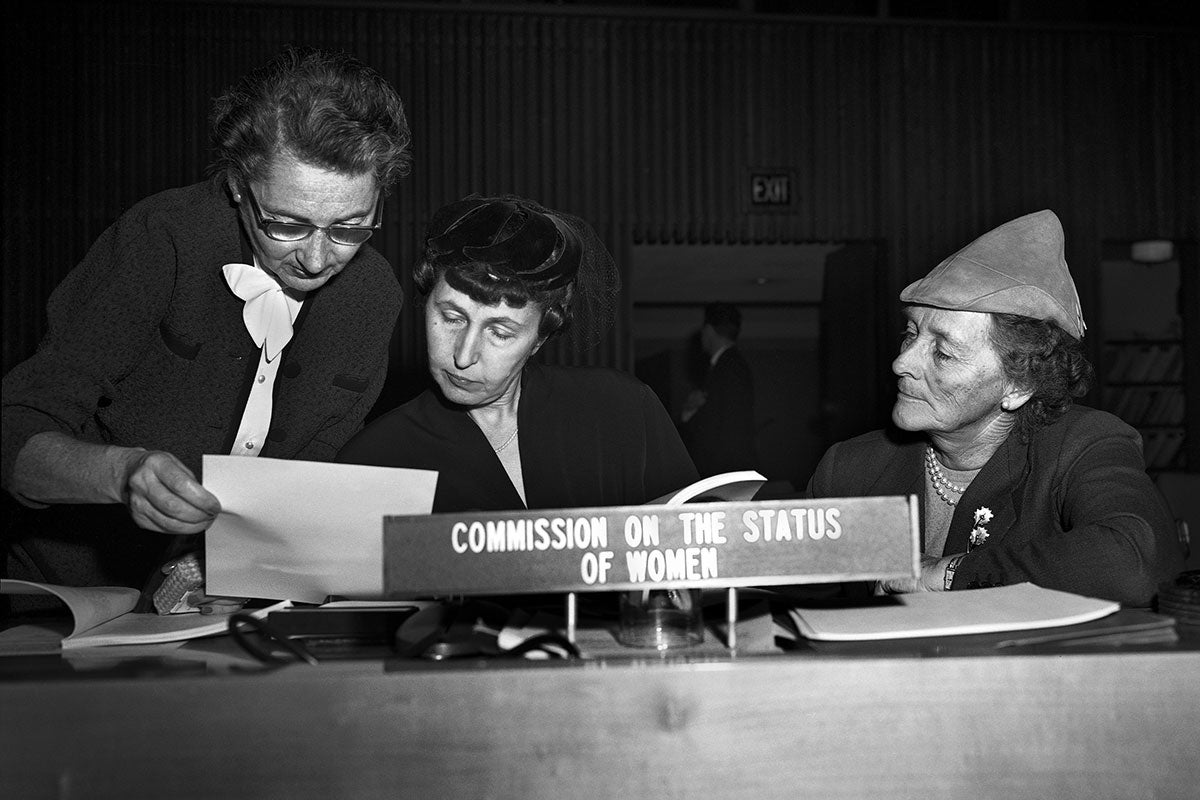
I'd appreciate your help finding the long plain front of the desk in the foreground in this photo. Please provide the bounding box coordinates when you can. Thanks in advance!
[0,648,1200,800]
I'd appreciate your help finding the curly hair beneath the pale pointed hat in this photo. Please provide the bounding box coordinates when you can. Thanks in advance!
[989,313,1096,441]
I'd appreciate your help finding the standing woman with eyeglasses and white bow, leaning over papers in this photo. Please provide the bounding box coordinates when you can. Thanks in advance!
[0,48,410,587]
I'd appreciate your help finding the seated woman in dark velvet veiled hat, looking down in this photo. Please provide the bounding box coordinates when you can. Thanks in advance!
[338,196,697,512]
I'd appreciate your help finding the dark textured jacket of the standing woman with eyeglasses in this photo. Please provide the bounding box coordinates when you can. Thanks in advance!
[0,182,401,585]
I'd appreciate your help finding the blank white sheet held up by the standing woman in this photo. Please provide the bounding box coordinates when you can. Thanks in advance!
[203,456,438,603]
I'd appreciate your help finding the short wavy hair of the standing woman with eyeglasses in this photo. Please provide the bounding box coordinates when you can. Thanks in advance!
[209,47,412,193]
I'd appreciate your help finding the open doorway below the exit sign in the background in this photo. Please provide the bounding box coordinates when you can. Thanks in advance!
[631,242,886,489]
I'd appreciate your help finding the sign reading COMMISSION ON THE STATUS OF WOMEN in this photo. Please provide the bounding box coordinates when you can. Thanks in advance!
[383,497,919,597]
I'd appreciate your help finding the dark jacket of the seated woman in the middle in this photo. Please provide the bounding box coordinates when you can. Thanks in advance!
[337,363,696,512]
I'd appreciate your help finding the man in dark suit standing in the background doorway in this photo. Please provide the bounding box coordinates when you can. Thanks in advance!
[680,302,756,476]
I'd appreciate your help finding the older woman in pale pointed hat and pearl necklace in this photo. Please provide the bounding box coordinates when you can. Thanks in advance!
[806,211,1182,606]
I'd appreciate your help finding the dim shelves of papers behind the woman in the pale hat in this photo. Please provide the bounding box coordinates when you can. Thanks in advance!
[1097,242,1200,475]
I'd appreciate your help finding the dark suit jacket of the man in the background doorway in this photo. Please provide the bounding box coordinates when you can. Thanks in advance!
[680,345,757,475]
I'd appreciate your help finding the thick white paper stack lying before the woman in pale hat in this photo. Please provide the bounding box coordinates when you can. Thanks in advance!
[791,583,1121,642]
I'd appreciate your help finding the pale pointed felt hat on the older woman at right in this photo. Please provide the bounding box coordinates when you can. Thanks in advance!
[900,210,1087,339]
